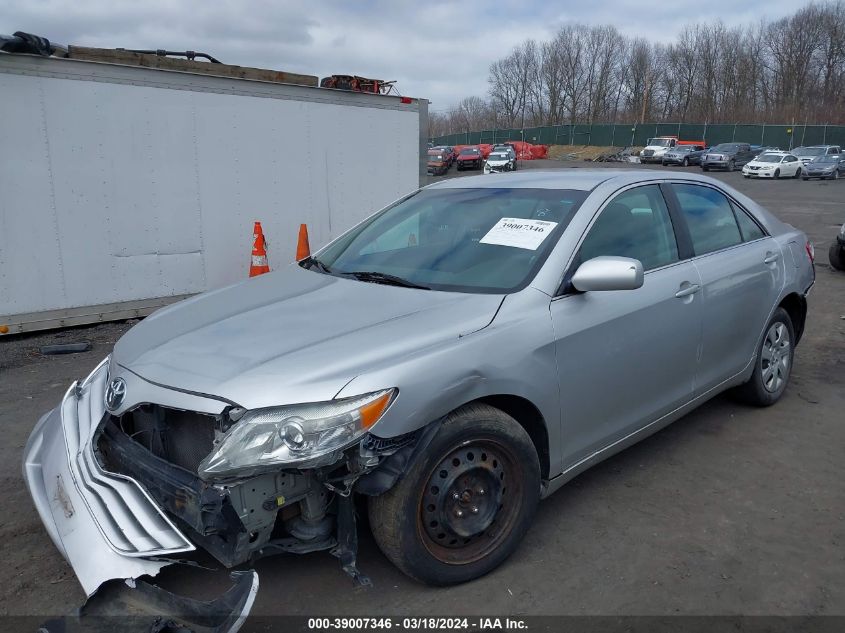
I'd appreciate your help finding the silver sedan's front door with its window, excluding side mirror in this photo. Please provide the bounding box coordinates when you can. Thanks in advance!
[551,184,702,468]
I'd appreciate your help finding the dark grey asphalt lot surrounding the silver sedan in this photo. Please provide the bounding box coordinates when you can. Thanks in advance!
[0,161,845,630]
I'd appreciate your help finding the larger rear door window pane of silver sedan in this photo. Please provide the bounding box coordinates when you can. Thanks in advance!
[673,184,742,255]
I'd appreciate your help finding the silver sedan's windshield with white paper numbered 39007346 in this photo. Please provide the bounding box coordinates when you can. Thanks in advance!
[311,188,587,293]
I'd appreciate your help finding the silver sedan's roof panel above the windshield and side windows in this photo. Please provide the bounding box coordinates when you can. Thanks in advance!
[425,168,719,191]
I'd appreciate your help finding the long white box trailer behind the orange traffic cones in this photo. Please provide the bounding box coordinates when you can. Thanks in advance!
[0,52,428,334]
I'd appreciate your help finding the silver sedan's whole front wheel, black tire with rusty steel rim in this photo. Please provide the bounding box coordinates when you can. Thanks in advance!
[369,404,540,585]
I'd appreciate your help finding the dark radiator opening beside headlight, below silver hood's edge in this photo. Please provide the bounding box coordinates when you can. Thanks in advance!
[110,404,217,473]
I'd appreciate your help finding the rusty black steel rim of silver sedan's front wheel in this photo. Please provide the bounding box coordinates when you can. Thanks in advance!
[417,439,523,565]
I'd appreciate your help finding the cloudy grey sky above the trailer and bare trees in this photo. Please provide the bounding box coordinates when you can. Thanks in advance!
[0,0,804,110]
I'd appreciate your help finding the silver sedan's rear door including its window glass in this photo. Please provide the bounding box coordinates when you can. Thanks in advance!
[670,183,784,395]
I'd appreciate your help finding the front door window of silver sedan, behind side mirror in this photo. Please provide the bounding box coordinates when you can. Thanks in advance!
[579,185,678,270]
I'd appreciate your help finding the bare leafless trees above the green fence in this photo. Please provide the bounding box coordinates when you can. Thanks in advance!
[430,0,845,136]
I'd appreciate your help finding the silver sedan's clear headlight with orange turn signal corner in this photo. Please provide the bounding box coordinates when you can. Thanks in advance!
[199,389,396,479]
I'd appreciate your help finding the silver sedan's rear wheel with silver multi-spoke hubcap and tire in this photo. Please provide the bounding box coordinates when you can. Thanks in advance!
[735,308,795,407]
